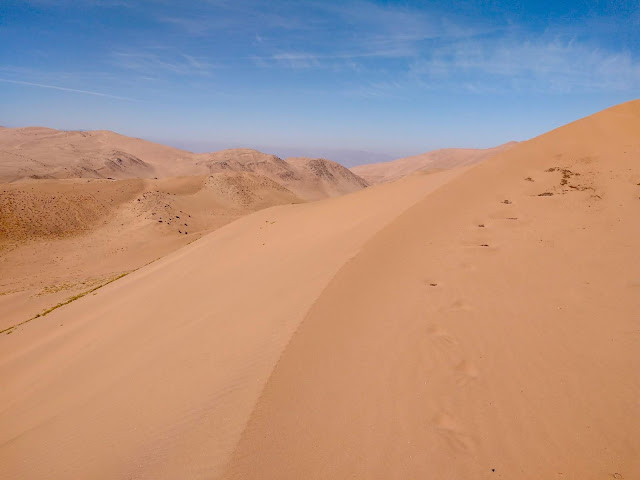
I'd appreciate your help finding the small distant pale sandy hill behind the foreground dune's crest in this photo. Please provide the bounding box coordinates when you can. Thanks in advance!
[351,142,518,185]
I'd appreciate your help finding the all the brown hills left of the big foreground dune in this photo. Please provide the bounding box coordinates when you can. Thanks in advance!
[0,127,367,330]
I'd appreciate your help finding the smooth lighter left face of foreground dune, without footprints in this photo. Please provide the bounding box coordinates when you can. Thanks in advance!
[0,171,459,479]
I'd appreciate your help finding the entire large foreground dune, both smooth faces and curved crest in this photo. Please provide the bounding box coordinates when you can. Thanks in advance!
[0,101,640,480]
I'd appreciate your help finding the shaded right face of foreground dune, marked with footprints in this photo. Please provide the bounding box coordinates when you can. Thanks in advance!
[224,101,640,479]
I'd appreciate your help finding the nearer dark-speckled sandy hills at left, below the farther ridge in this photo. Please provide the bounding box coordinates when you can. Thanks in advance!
[0,172,302,330]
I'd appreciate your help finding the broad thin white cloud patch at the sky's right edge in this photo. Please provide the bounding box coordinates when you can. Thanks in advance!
[409,39,640,92]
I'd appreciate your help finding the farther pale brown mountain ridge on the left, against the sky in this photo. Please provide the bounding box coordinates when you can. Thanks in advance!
[0,127,367,200]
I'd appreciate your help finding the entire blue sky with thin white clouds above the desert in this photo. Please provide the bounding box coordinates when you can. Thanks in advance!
[0,0,640,163]
